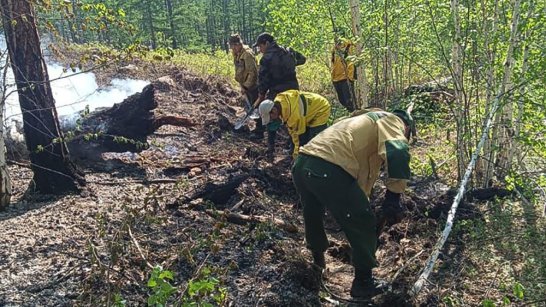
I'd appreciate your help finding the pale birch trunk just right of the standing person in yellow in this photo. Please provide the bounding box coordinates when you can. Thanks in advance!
[349,0,369,109]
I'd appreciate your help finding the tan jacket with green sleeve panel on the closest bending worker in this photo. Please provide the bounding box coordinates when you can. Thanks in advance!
[300,110,410,197]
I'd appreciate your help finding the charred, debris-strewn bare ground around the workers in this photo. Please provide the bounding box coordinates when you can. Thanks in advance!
[0,59,500,306]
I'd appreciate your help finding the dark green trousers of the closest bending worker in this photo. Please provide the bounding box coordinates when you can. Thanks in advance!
[292,154,377,270]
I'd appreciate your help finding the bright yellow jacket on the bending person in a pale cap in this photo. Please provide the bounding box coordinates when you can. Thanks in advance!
[275,90,331,155]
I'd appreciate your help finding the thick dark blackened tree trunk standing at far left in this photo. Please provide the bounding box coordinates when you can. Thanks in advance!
[0,0,84,194]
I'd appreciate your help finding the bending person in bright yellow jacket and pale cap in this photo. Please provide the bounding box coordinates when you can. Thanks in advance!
[258,90,331,158]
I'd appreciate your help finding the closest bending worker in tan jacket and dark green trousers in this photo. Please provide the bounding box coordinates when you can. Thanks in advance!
[292,109,413,298]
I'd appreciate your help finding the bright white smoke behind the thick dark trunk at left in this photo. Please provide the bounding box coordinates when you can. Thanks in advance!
[0,39,150,135]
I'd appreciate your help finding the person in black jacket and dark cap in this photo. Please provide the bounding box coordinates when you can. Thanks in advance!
[253,33,306,155]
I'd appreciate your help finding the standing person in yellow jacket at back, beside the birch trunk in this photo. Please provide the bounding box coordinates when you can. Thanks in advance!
[331,38,356,112]
